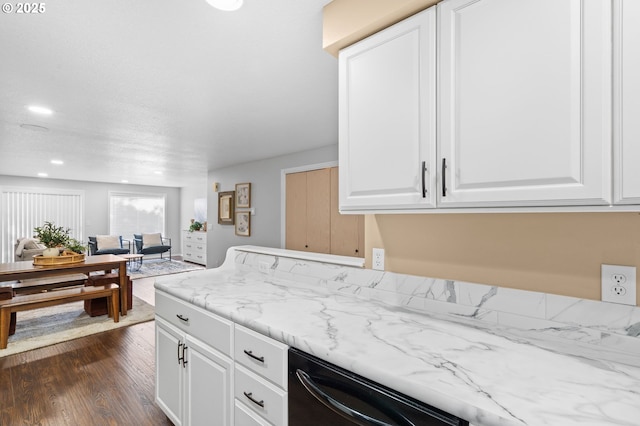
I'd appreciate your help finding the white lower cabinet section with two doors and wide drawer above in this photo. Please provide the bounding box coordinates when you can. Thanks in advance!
[156,292,233,425]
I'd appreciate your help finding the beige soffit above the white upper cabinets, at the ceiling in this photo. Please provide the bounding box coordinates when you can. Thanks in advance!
[322,0,440,56]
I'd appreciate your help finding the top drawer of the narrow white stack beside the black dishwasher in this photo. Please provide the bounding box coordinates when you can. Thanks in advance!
[233,324,289,390]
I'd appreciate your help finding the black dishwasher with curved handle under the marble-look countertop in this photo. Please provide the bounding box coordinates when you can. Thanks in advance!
[288,348,469,426]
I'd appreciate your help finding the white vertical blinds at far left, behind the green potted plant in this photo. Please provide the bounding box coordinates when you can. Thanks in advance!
[0,188,84,262]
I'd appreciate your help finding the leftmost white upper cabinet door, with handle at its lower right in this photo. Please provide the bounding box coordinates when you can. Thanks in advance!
[339,8,436,212]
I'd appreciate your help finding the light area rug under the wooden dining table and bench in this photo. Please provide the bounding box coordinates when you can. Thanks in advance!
[0,296,155,358]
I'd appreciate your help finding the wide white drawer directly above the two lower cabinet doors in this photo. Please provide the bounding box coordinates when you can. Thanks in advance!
[156,291,233,356]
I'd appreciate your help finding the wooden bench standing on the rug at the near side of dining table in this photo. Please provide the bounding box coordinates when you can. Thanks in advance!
[0,284,120,349]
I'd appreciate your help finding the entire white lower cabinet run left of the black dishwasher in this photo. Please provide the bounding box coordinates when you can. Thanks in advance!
[156,291,288,426]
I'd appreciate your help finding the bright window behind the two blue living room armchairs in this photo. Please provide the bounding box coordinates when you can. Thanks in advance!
[109,192,166,240]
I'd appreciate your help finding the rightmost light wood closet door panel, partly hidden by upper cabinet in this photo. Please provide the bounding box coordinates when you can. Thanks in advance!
[331,167,364,257]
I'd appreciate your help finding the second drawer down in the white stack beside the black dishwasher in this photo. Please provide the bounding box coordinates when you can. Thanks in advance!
[233,363,289,425]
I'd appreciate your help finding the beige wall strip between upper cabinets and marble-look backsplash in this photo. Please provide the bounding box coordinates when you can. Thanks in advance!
[365,213,640,305]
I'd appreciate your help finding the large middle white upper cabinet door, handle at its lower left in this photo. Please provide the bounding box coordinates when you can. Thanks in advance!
[438,0,612,207]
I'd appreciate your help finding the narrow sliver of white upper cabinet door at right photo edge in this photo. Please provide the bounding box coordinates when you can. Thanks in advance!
[613,0,640,204]
